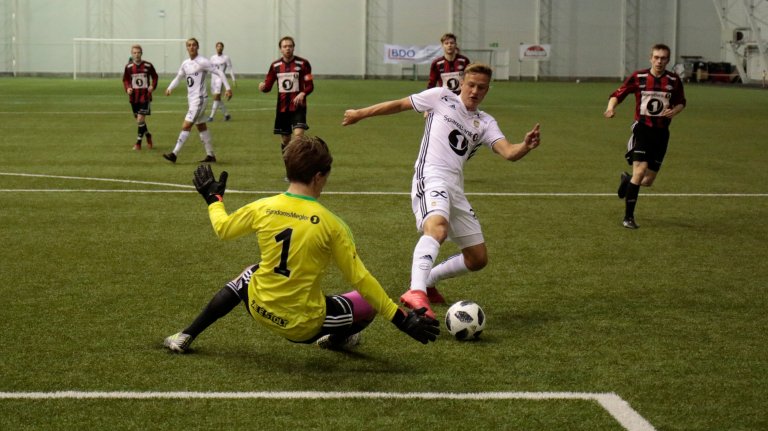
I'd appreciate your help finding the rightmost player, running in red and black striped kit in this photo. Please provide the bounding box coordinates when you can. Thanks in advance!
[603,44,686,229]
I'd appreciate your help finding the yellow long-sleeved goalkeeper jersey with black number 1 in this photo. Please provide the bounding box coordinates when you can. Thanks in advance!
[208,192,397,341]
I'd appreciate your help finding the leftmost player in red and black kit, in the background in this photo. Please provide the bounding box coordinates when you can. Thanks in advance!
[123,45,157,150]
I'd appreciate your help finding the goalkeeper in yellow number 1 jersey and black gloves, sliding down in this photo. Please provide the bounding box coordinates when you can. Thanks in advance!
[164,136,440,352]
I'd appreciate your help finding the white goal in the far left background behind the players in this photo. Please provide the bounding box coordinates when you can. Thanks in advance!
[72,37,186,79]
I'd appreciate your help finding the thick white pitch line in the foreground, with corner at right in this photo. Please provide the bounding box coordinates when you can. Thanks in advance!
[0,391,656,431]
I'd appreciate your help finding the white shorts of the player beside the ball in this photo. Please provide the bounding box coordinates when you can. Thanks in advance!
[411,183,485,249]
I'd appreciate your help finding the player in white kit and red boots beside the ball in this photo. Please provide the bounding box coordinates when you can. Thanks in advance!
[342,64,540,318]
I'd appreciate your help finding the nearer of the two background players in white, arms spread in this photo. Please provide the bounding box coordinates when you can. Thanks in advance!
[163,38,232,163]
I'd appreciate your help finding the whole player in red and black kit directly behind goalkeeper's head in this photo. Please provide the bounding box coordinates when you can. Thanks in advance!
[259,36,315,154]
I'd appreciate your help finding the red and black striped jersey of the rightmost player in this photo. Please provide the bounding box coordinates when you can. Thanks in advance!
[610,69,686,128]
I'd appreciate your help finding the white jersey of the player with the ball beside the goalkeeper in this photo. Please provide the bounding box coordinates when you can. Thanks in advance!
[410,87,504,193]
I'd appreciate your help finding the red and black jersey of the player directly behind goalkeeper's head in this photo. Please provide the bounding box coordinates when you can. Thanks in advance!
[264,56,315,112]
